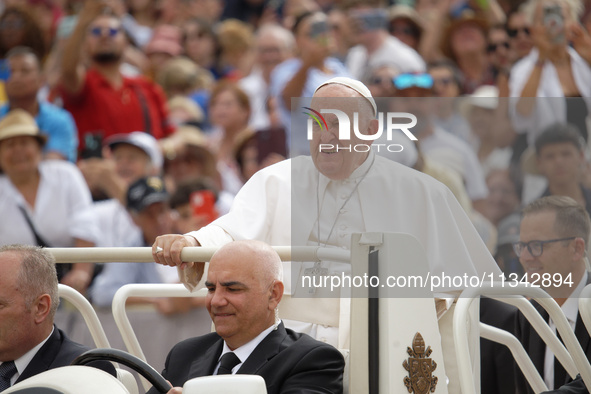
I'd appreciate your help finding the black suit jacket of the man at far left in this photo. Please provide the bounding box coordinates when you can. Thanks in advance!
[15,325,117,384]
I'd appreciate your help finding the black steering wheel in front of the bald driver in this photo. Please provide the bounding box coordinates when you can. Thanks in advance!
[70,349,172,393]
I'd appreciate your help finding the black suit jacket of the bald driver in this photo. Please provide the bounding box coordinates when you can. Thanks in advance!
[148,323,345,394]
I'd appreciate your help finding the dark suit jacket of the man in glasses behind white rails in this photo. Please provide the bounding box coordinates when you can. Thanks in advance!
[516,284,591,394]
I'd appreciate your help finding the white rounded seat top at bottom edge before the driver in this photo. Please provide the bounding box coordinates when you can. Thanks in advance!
[183,375,267,394]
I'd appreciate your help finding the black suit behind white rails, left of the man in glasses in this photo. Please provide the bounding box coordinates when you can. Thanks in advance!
[480,297,517,394]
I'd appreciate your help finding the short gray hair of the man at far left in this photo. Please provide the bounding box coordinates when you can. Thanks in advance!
[0,245,60,319]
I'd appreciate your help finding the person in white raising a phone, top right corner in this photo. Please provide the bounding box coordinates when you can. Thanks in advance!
[509,0,591,145]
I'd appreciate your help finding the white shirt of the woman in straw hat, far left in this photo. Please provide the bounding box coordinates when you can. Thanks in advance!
[0,160,100,247]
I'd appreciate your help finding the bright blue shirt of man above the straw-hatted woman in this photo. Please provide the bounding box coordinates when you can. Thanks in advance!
[0,101,78,163]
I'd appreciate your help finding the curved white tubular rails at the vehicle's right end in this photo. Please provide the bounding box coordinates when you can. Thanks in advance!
[454,283,591,393]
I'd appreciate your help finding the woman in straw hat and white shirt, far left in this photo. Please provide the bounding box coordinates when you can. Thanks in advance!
[0,109,99,292]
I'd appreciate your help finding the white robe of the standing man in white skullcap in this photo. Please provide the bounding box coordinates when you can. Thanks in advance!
[185,153,501,390]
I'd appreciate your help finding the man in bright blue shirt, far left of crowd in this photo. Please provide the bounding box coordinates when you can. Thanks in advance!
[0,47,78,162]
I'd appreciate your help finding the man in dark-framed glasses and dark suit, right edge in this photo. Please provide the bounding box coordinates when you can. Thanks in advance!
[513,196,591,393]
